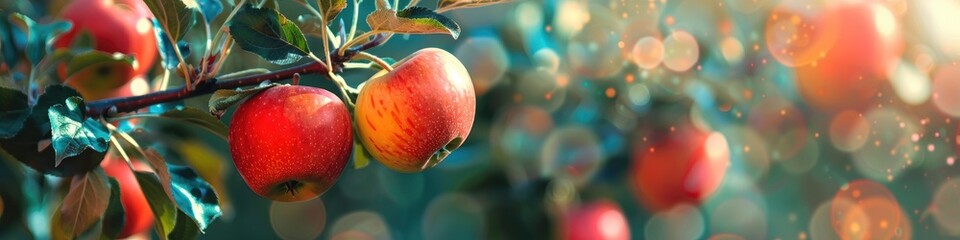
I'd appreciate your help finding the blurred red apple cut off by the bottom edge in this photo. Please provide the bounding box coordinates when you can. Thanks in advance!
[563,201,630,240]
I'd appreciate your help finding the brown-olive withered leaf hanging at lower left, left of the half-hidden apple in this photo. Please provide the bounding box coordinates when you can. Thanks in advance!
[60,169,110,237]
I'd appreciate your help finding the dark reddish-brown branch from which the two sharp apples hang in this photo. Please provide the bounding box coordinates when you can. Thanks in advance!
[86,34,386,118]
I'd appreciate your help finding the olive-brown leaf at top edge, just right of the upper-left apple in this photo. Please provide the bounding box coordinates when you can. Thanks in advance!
[143,0,199,42]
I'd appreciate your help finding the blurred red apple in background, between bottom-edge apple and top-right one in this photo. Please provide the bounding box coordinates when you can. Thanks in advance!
[631,125,730,211]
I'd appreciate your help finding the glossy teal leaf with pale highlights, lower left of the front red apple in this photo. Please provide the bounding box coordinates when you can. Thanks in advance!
[167,163,222,232]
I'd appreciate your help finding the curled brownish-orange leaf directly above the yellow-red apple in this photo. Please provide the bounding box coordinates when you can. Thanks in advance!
[367,7,460,39]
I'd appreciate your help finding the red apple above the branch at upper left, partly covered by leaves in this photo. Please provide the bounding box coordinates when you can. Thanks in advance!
[55,0,157,88]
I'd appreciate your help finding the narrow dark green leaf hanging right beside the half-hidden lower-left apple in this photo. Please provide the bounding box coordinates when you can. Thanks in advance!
[133,171,177,239]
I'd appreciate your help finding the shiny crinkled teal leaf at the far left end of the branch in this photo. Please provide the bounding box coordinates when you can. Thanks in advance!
[48,97,110,166]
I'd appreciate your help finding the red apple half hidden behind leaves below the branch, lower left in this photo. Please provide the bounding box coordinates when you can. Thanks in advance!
[100,155,153,238]
